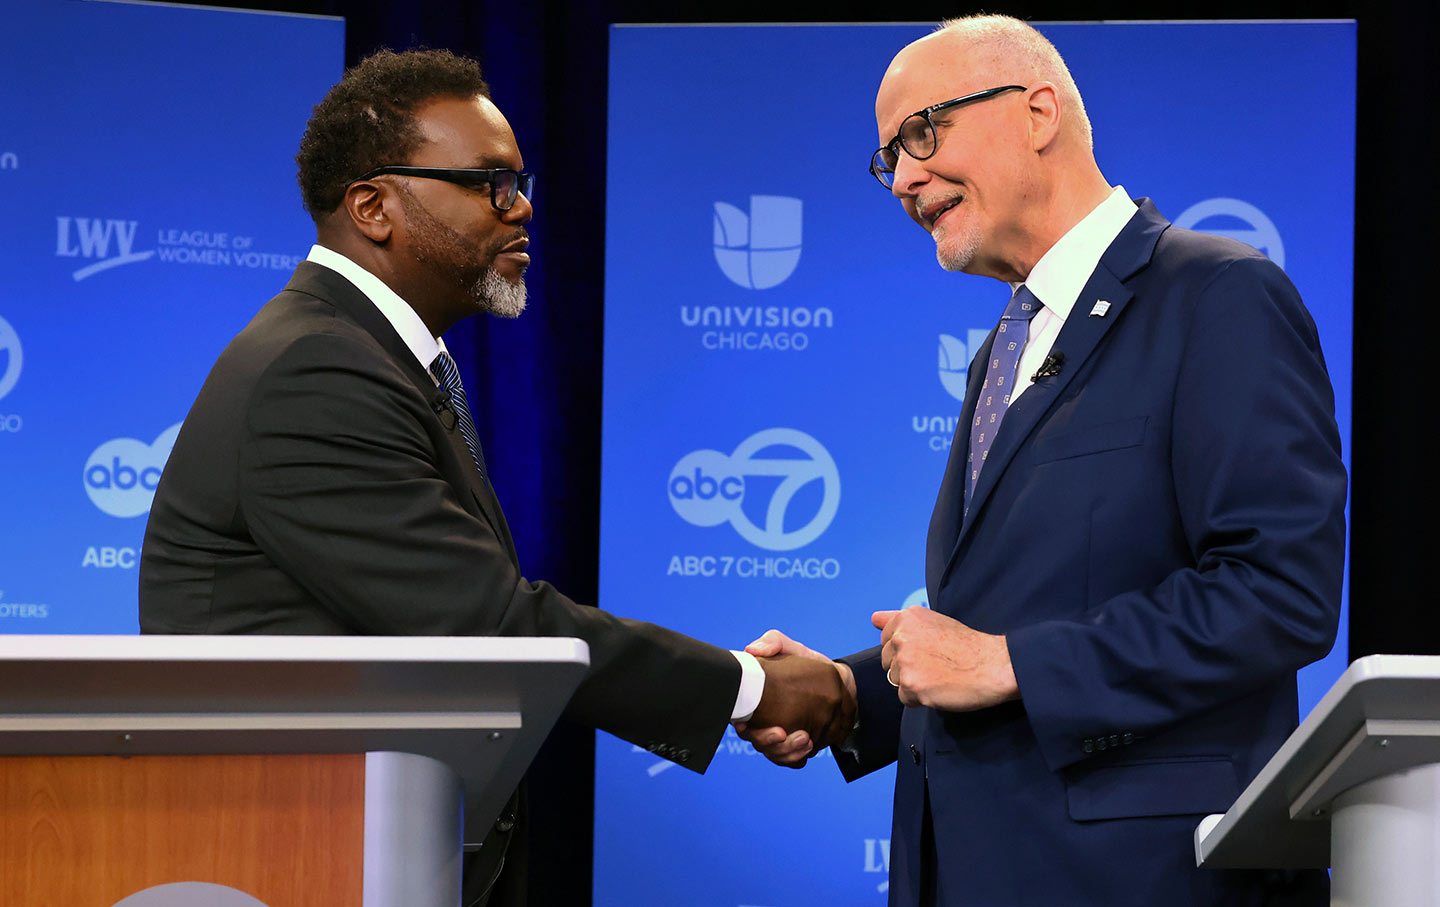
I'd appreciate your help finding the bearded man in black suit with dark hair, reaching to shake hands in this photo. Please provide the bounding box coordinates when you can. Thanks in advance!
[140,52,854,903]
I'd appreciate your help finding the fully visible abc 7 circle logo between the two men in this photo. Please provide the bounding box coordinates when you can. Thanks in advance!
[668,428,840,551]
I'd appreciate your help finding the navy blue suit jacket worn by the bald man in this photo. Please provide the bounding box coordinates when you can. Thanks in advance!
[837,200,1346,907]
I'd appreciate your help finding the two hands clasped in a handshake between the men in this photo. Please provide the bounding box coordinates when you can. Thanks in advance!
[736,631,857,769]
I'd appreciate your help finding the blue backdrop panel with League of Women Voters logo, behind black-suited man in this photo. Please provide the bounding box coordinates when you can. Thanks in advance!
[0,0,344,633]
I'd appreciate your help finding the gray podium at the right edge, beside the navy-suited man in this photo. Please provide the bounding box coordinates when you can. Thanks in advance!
[1195,655,1440,907]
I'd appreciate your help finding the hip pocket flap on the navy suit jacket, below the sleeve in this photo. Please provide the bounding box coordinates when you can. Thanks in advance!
[1066,759,1240,822]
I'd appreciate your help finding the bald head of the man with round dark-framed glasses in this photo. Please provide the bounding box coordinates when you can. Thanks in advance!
[876,16,1109,281]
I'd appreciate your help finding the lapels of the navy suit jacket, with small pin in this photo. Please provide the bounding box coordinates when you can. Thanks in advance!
[932,199,1169,578]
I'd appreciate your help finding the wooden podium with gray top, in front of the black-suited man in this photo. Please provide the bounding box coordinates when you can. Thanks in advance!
[0,636,589,907]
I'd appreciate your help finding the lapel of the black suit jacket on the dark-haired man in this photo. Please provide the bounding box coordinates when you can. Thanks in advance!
[285,262,513,535]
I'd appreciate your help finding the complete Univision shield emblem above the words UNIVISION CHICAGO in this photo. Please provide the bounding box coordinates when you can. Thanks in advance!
[714,196,801,289]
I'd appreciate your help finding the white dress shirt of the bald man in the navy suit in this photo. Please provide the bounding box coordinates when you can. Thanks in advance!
[1009,186,1139,406]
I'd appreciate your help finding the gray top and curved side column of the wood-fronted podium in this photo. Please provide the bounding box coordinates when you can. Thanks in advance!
[0,636,589,907]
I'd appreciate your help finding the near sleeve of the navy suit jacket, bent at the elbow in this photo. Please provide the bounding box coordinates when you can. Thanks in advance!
[1008,258,1346,769]
